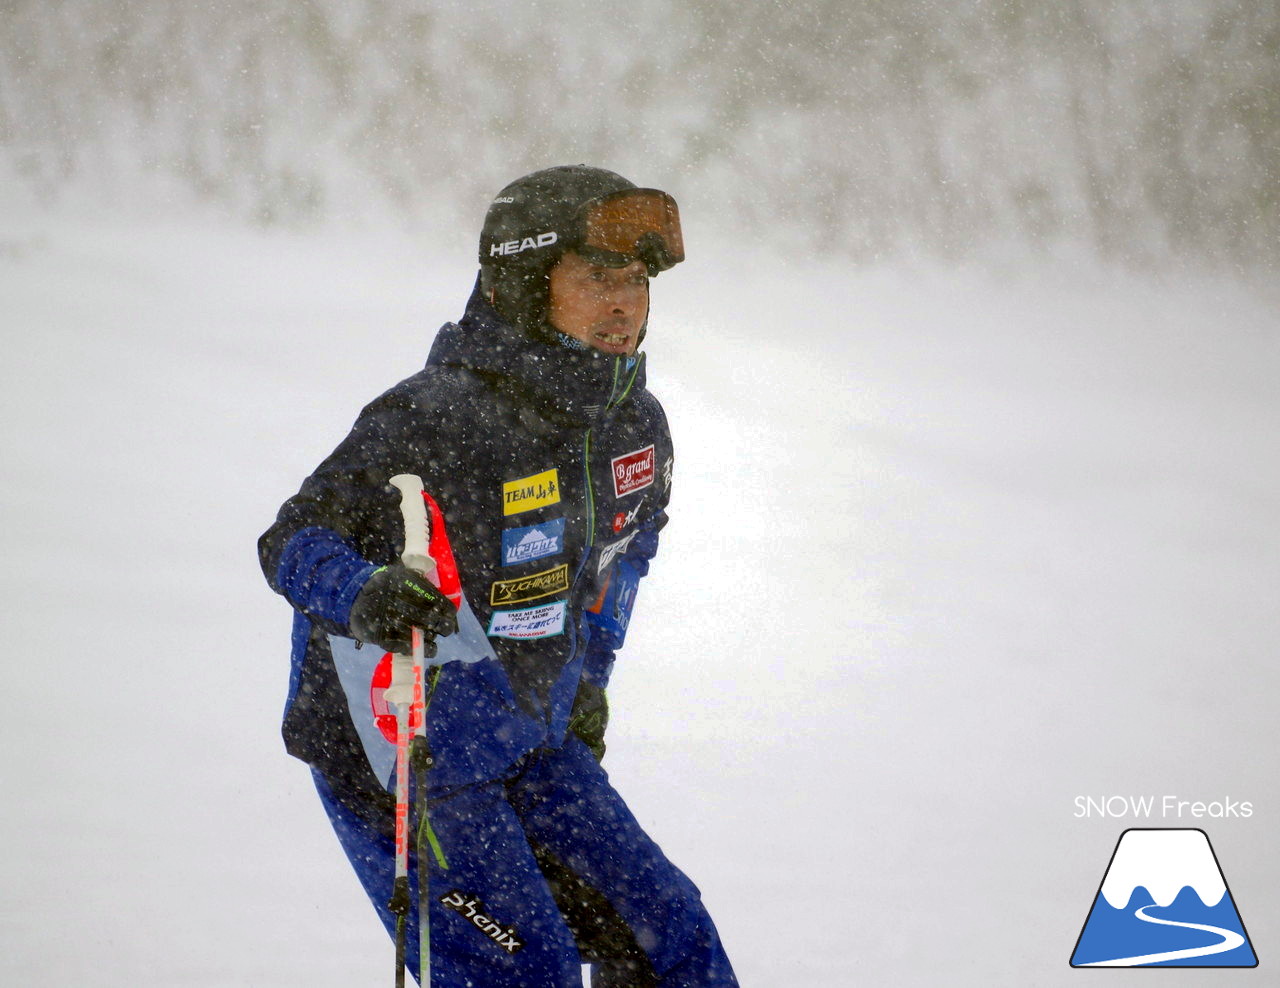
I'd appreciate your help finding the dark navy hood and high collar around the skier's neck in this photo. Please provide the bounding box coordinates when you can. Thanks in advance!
[426,279,645,425]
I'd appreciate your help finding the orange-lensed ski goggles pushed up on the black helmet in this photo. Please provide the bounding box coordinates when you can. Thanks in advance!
[577,188,685,275]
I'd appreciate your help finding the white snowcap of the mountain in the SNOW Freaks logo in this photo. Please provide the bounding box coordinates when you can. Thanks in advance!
[1102,829,1226,909]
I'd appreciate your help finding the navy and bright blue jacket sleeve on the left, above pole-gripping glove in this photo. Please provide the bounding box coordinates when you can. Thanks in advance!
[259,385,422,635]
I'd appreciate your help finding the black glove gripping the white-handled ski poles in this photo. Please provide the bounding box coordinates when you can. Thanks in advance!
[347,563,458,655]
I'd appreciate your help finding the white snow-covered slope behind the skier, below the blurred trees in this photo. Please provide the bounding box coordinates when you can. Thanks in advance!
[0,210,1280,988]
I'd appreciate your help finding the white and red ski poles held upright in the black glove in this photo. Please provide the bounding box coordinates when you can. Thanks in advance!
[385,474,439,988]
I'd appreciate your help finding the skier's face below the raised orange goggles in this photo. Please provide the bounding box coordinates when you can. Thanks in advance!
[548,251,649,356]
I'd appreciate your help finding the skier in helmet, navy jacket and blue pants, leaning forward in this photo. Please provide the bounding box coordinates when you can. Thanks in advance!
[259,165,737,988]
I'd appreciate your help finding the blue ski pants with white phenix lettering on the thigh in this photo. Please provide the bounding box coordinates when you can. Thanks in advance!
[315,735,737,988]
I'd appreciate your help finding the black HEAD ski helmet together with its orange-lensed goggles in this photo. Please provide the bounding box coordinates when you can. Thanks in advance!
[480,165,685,334]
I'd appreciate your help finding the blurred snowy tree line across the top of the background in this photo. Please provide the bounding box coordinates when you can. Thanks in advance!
[0,0,1280,266]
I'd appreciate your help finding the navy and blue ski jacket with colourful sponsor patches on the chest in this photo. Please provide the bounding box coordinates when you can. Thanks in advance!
[259,281,672,800]
